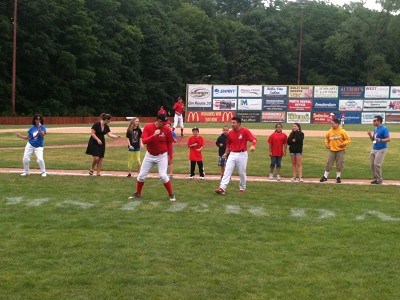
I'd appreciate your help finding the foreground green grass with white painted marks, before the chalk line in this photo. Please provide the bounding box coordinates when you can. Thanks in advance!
[0,174,400,299]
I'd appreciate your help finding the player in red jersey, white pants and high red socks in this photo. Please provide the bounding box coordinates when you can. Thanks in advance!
[129,114,176,201]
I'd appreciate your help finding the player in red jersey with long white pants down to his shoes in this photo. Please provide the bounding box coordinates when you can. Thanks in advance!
[215,117,257,195]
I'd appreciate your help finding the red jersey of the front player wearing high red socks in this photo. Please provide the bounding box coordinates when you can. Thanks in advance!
[142,123,174,159]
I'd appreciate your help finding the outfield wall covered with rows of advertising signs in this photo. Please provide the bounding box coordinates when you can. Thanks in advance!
[186,84,400,124]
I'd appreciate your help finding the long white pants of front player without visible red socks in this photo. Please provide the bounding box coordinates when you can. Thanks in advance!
[219,151,248,190]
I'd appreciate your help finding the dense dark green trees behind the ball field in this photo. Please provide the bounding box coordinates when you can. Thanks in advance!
[0,0,400,116]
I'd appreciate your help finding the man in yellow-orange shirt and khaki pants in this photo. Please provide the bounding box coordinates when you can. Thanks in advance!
[319,119,350,183]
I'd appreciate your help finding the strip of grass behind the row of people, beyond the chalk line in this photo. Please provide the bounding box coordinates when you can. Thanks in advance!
[0,133,400,180]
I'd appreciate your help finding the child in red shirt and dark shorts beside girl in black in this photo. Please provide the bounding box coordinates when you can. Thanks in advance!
[267,123,287,181]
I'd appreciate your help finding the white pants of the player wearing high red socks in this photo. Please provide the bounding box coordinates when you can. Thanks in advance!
[137,151,169,183]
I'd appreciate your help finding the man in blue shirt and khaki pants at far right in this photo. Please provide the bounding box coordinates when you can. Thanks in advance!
[368,116,390,184]
